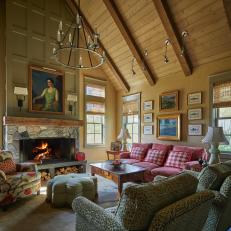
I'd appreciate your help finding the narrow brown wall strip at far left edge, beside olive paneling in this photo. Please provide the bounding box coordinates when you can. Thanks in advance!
[0,0,6,148]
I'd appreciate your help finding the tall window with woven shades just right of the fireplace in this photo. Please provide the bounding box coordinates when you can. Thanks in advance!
[85,78,106,145]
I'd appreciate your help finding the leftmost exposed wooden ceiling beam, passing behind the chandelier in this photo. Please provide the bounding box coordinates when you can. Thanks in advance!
[66,0,130,92]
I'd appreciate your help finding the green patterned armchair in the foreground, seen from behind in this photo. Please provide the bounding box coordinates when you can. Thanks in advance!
[72,173,214,231]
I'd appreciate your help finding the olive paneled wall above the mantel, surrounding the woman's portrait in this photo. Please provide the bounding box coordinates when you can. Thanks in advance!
[6,0,79,118]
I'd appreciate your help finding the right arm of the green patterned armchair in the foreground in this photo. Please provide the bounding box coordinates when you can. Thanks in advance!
[149,191,214,231]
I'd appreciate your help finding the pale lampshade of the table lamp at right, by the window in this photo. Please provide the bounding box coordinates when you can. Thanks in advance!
[202,127,229,144]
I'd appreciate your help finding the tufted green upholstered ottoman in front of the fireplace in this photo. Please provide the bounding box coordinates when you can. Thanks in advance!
[46,173,97,207]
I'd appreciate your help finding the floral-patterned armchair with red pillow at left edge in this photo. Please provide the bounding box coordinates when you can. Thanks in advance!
[0,151,41,207]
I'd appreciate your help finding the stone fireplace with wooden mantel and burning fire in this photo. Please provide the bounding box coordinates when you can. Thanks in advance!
[3,117,83,164]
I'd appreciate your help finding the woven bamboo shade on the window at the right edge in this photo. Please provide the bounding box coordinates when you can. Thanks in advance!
[213,80,231,108]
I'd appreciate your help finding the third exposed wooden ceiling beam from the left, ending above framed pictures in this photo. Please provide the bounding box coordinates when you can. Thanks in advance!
[153,0,192,76]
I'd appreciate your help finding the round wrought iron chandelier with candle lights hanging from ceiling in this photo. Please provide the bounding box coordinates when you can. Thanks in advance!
[53,1,105,69]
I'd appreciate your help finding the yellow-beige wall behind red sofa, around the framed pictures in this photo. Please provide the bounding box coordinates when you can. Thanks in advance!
[117,57,231,145]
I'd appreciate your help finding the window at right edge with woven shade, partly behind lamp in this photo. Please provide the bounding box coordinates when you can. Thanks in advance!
[213,80,231,153]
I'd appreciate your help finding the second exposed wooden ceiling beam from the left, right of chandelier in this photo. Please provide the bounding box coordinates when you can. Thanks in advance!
[103,0,155,85]
